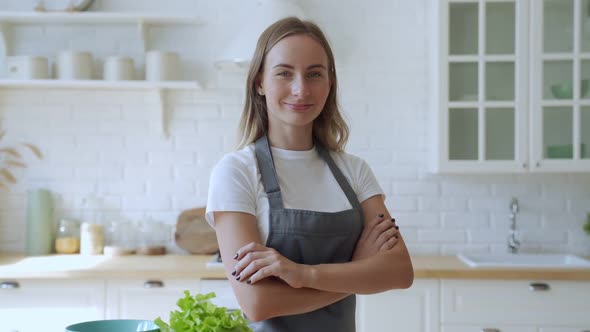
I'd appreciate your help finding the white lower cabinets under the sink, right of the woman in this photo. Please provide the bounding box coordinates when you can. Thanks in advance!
[357,279,590,332]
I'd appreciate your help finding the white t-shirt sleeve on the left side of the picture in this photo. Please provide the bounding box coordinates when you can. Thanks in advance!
[205,155,256,227]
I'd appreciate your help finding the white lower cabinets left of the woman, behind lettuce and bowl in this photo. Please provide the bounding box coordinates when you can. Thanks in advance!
[0,279,239,332]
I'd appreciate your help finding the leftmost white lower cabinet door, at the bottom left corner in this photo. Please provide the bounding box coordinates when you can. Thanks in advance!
[0,280,105,332]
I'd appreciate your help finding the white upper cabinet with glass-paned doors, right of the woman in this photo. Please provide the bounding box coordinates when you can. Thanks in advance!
[431,0,590,173]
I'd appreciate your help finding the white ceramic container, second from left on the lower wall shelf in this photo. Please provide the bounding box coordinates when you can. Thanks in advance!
[57,51,93,80]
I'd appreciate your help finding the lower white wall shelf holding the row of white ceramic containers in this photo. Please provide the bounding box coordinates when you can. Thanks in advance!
[0,79,202,90]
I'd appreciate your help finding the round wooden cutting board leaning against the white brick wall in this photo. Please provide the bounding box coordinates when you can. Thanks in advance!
[174,208,219,255]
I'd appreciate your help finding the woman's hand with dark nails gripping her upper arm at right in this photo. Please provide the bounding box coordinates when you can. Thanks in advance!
[352,214,399,261]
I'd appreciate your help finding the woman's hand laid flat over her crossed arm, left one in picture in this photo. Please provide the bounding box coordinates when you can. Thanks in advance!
[232,242,306,288]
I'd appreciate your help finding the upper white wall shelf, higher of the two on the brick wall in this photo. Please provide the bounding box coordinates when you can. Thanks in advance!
[0,12,204,24]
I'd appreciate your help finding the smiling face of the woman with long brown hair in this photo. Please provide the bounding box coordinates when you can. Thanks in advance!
[257,34,330,129]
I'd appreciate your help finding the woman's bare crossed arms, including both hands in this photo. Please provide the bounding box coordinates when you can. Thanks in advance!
[215,195,414,321]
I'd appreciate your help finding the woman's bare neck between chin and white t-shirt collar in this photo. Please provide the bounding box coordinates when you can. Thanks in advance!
[268,125,313,151]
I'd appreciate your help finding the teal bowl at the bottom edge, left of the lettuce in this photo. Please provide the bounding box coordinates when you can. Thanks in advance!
[66,319,160,332]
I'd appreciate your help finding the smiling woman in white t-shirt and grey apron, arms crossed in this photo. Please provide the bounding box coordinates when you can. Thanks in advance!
[207,18,413,331]
